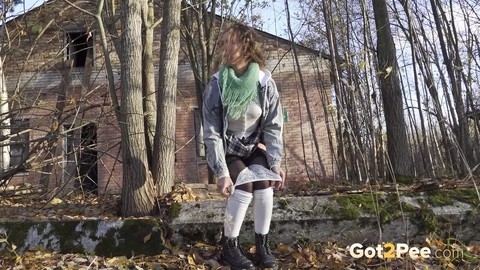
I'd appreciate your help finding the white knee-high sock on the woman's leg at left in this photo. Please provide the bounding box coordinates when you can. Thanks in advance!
[224,189,253,238]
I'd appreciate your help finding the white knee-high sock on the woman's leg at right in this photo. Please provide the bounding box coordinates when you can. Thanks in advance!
[253,187,273,234]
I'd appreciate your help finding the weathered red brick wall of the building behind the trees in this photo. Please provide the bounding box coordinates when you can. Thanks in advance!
[4,1,335,192]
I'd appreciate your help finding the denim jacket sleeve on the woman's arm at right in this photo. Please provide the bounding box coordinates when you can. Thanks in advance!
[263,79,283,169]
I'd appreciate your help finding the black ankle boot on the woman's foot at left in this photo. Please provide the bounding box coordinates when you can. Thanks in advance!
[220,237,255,270]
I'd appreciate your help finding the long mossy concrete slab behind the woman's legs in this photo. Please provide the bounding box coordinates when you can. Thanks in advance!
[0,185,480,256]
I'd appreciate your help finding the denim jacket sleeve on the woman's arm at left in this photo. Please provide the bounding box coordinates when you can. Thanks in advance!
[202,80,230,178]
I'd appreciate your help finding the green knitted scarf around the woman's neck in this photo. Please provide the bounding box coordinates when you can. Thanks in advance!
[220,62,260,119]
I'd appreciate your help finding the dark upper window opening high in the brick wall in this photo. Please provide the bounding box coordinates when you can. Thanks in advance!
[67,32,93,67]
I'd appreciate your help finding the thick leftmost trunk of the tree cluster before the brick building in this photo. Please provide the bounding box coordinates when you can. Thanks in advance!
[119,0,155,216]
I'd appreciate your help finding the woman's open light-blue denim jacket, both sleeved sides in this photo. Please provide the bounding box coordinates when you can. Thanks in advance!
[203,70,283,178]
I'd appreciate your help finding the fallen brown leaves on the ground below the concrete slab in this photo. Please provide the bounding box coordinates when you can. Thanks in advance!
[0,240,480,270]
